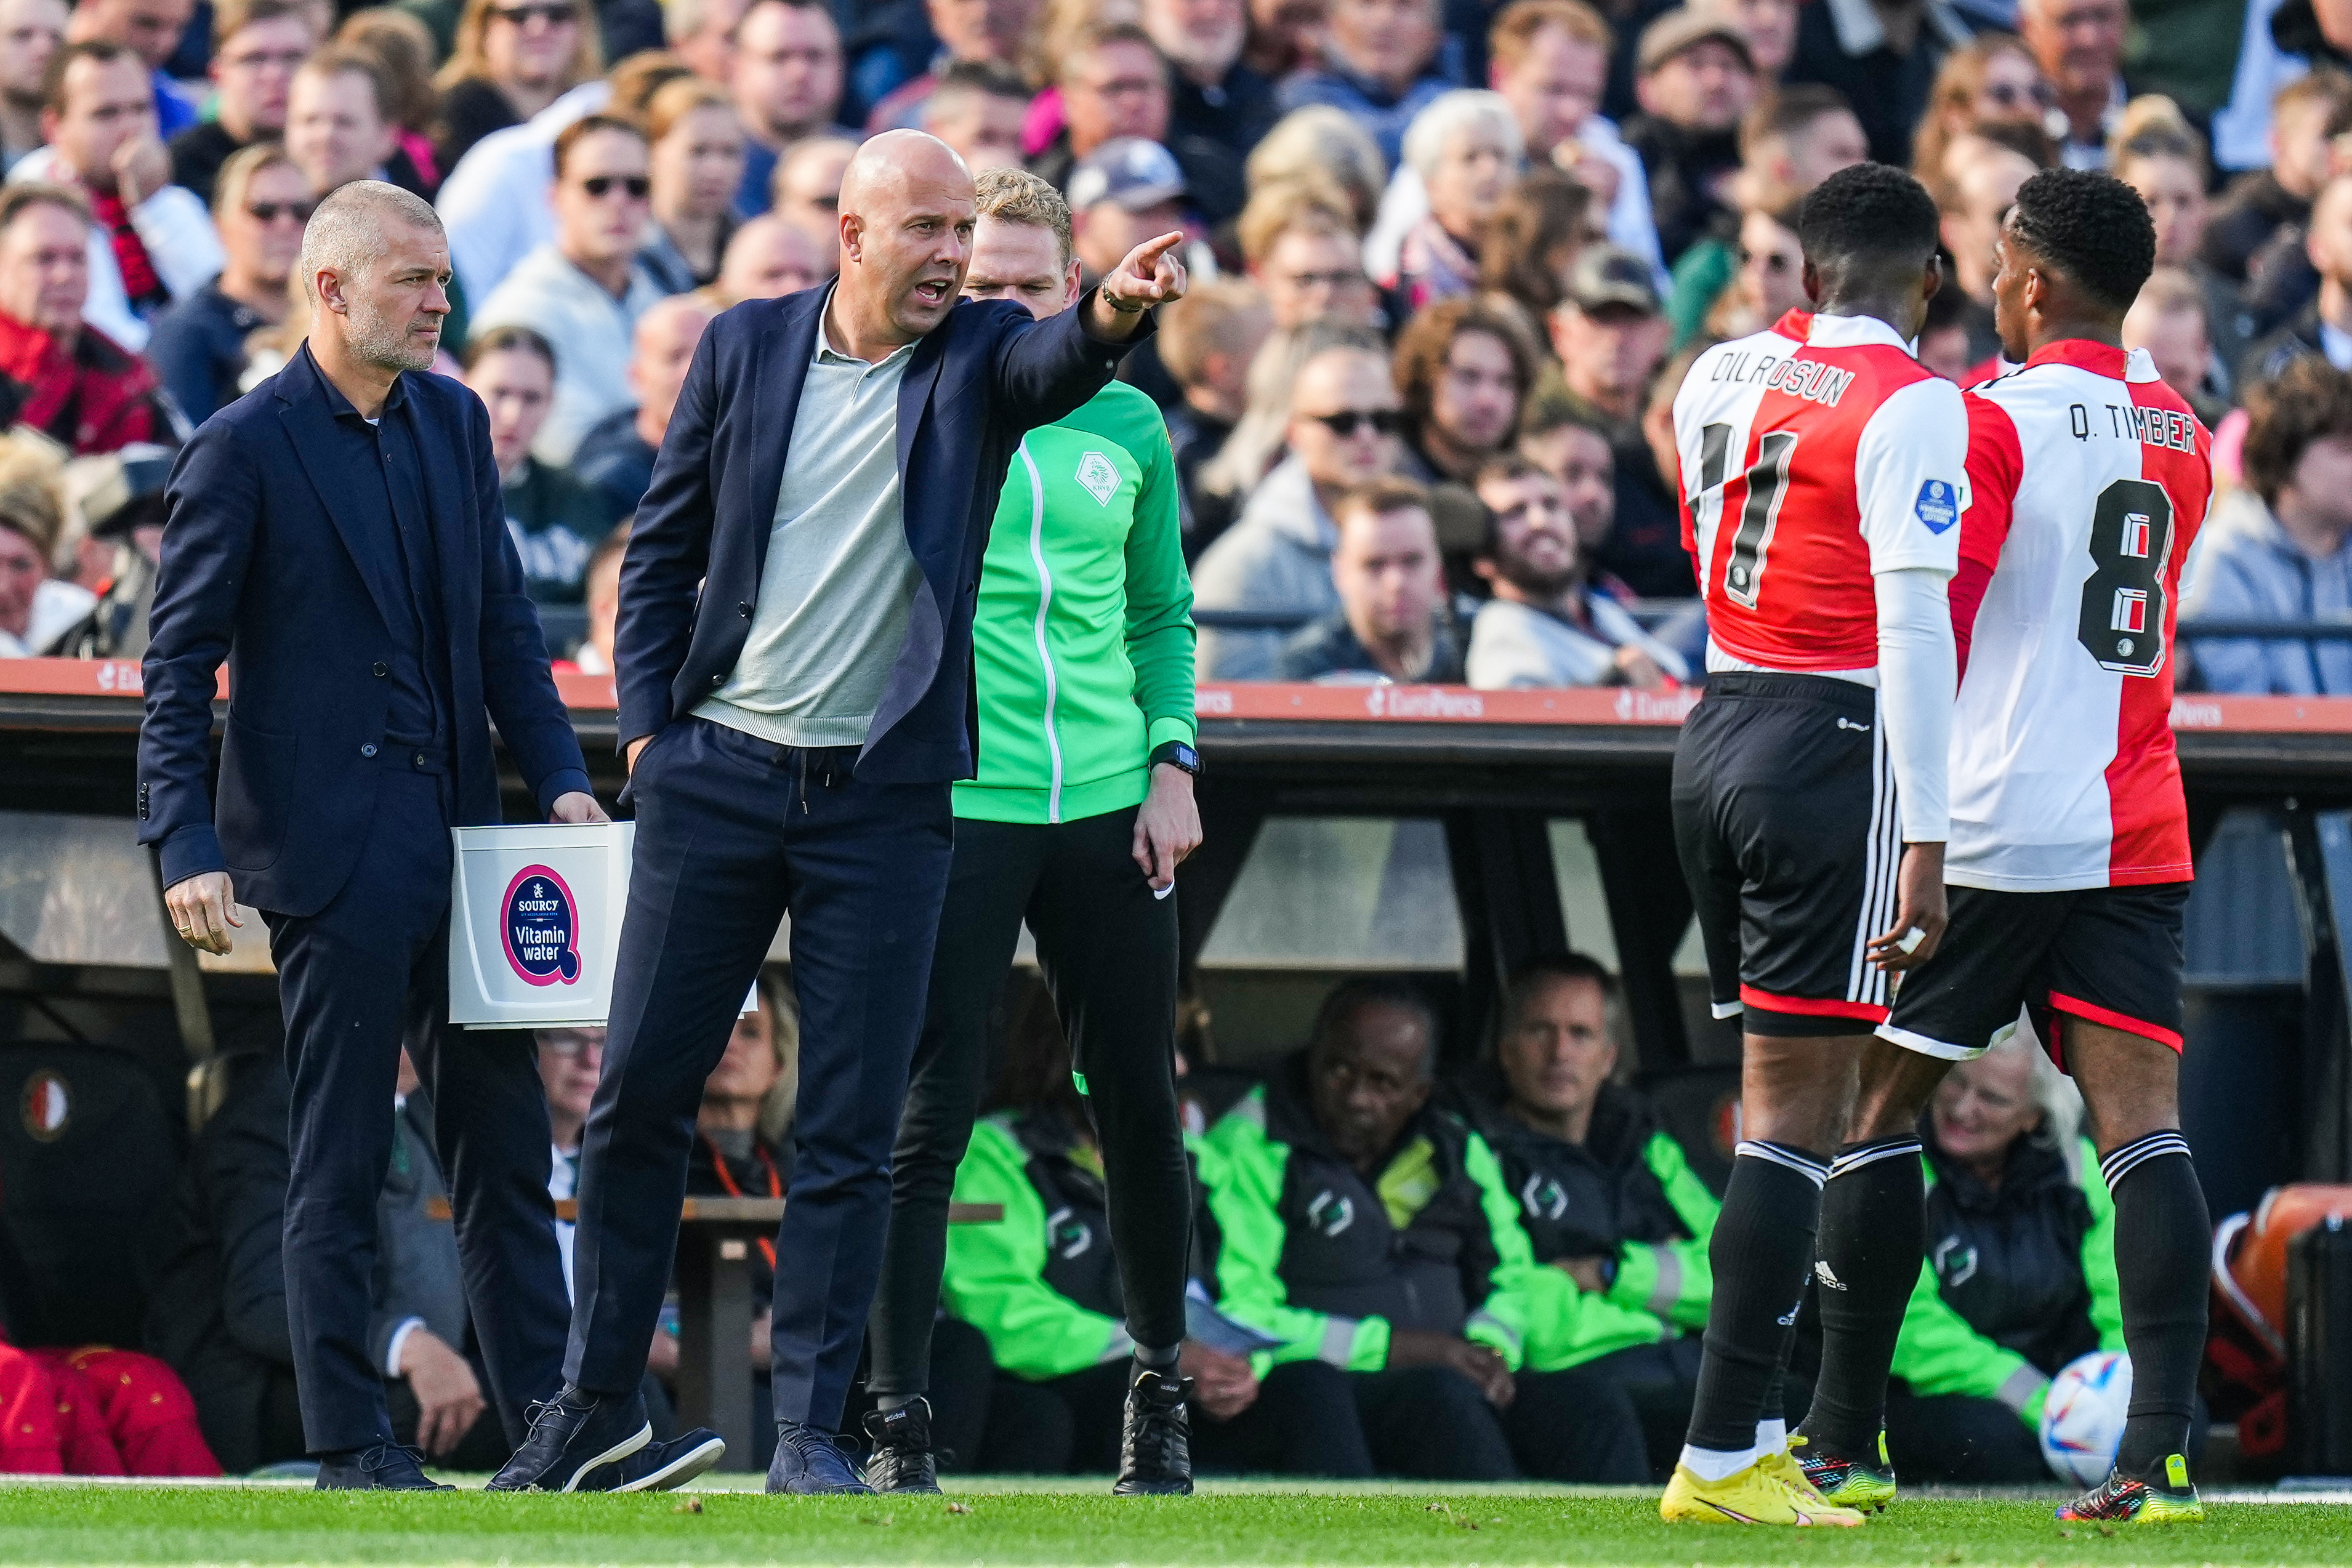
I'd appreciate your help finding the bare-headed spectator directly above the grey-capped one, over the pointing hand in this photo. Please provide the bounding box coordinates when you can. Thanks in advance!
[1030,21,1249,227]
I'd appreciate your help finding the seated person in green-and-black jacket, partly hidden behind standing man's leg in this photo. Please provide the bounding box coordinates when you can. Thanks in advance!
[941,1037,1374,1479]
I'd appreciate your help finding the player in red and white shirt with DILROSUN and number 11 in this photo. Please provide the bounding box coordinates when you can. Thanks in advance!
[1661,164,1967,1526]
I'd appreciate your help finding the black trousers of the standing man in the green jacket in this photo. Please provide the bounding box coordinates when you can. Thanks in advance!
[870,806,1193,1399]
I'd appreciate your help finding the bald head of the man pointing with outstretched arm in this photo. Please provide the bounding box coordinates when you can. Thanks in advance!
[832,132,976,344]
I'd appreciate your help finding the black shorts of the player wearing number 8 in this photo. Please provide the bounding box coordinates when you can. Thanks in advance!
[1879,882,2189,1067]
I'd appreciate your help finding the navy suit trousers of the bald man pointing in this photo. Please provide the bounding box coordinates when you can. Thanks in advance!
[565,717,950,1432]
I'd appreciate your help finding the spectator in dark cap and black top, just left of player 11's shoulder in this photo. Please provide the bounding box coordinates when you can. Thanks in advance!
[1548,244,1693,597]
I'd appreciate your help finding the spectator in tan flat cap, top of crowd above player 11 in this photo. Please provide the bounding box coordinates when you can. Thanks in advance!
[1625,5,1757,266]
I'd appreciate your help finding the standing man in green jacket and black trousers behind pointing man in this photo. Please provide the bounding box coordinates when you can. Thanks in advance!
[866,169,1199,1493]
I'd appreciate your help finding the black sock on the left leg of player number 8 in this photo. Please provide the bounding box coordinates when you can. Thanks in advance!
[1799,1133,1927,1465]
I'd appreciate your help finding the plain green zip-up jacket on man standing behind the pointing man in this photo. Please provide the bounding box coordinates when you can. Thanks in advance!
[955,381,1195,823]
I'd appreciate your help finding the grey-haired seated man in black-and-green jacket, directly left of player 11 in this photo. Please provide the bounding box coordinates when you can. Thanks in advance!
[1460,952,1719,1481]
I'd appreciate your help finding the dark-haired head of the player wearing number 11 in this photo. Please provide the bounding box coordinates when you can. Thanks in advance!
[1797,162,1943,336]
